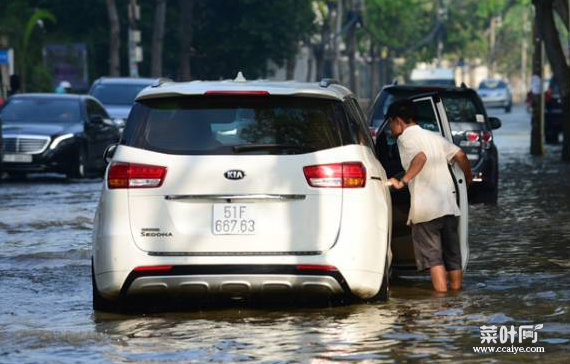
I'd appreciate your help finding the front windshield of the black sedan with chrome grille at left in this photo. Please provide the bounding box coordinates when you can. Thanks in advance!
[0,98,81,123]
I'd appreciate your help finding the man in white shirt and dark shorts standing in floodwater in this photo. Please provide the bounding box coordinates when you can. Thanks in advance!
[386,100,473,292]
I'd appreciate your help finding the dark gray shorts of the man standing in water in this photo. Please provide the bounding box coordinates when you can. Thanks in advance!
[412,215,461,271]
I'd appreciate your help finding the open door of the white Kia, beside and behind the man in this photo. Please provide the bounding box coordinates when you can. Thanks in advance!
[376,94,469,269]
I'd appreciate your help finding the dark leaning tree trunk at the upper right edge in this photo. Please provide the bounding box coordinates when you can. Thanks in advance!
[533,0,570,162]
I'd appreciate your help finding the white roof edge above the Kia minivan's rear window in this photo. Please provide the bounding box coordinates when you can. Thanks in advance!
[136,80,352,101]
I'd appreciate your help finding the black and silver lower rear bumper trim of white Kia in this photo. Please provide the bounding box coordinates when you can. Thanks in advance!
[117,265,350,299]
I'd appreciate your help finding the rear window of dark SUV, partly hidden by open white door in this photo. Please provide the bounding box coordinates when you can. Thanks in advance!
[372,90,485,127]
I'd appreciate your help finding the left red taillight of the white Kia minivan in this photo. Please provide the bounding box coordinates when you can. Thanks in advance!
[107,162,166,189]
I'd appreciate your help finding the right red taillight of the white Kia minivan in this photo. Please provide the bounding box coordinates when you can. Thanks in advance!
[303,162,366,188]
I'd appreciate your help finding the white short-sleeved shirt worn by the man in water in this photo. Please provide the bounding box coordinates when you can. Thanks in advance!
[398,125,461,225]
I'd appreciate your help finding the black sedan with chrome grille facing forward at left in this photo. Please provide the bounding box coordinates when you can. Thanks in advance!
[0,94,120,178]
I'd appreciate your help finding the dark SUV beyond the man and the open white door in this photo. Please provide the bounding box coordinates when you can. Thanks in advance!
[369,85,501,203]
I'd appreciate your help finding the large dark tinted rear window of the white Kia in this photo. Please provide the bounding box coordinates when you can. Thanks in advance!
[122,96,347,155]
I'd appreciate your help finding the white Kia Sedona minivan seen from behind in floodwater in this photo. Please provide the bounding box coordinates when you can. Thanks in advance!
[93,77,392,310]
